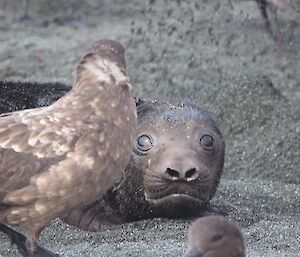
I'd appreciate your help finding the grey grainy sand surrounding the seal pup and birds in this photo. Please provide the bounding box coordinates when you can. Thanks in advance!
[0,0,300,257]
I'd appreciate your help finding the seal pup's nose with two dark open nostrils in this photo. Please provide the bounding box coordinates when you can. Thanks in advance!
[164,167,199,181]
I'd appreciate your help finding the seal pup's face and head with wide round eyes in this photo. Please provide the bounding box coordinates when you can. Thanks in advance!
[134,101,225,217]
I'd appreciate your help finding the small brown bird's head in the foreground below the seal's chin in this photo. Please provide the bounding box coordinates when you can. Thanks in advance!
[183,216,245,257]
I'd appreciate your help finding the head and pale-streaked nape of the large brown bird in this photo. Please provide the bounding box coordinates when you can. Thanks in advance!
[74,39,131,89]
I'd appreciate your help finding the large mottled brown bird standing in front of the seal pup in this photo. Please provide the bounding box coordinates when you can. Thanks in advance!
[0,40,137,256]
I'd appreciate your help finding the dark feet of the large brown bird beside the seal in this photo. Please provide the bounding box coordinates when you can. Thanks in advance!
[0,224,59,257]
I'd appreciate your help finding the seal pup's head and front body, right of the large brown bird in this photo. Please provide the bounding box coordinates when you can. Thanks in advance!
[61,99,225,231]
